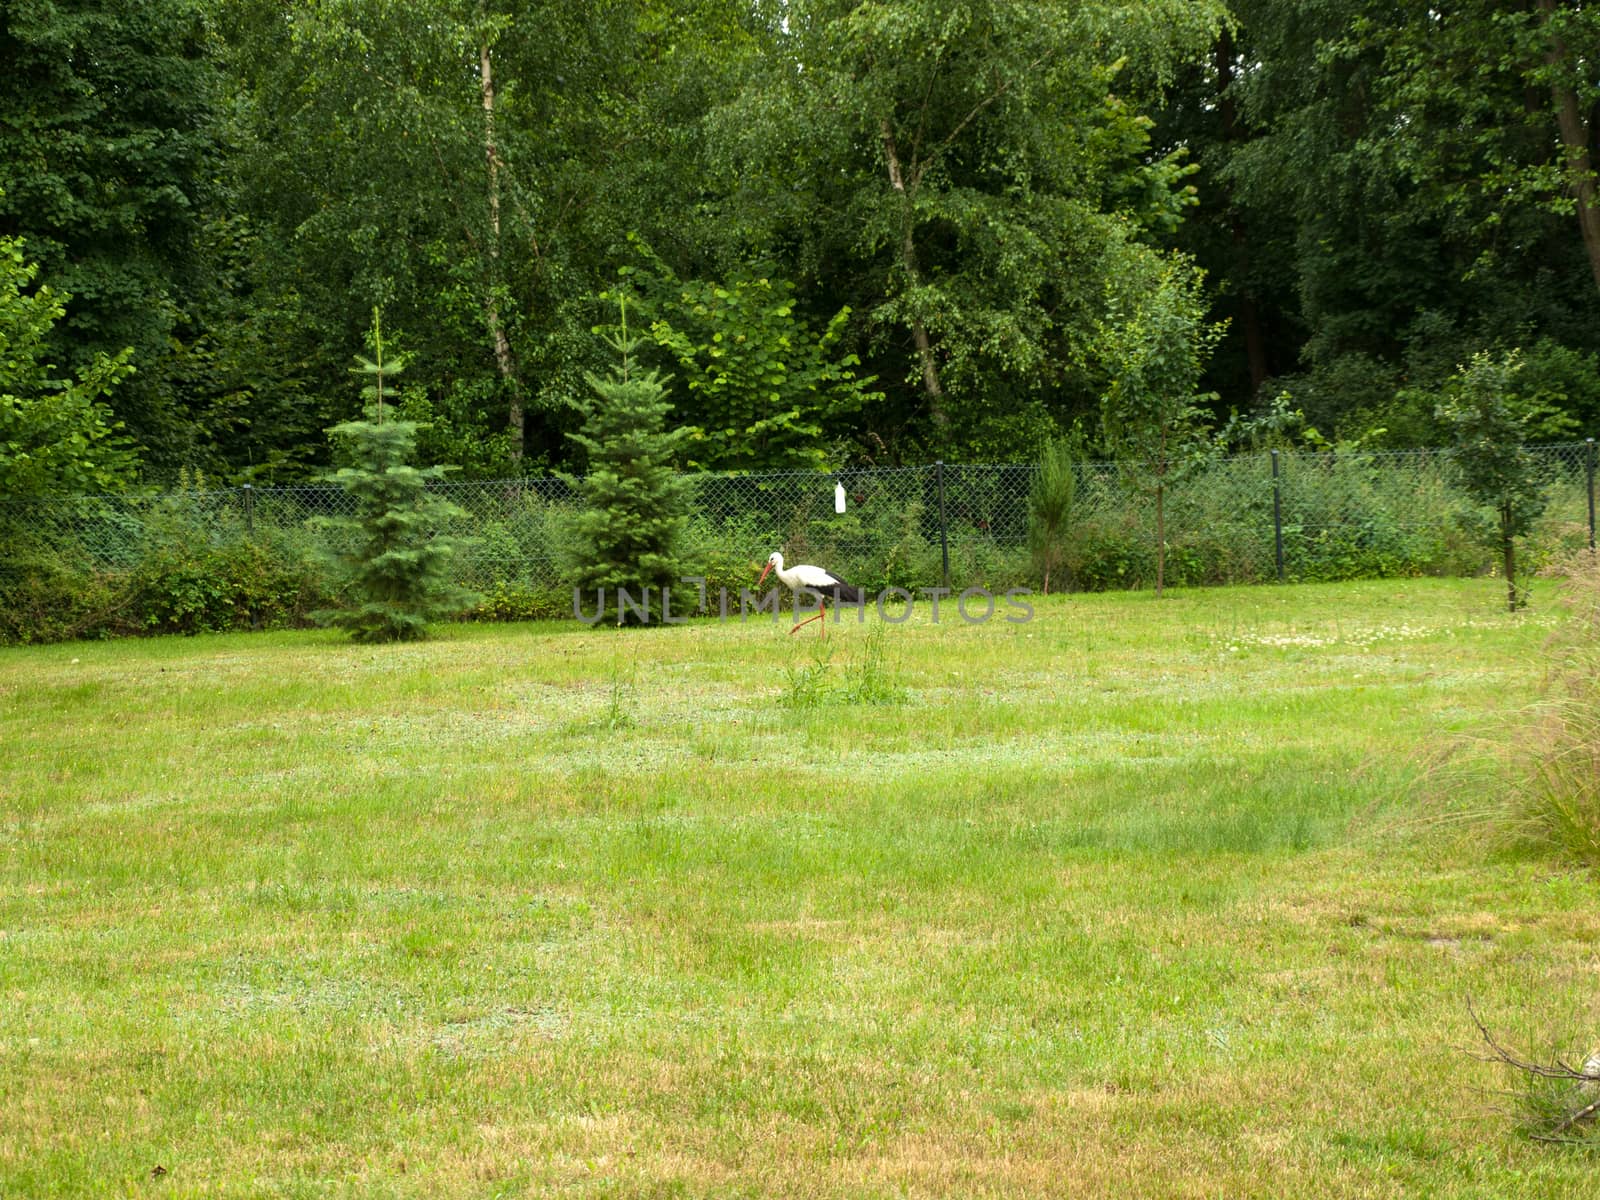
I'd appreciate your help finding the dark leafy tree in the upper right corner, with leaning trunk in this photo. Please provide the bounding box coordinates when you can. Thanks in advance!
[1157,0,1600,445]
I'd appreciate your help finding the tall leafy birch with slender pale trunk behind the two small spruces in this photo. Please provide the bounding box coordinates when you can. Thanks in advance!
[229,0,764,474]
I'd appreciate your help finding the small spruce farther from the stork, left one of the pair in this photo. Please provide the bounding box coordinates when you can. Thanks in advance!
[317,309,475,642]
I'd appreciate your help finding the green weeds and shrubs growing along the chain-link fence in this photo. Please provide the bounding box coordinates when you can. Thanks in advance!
[0,440,1595,642]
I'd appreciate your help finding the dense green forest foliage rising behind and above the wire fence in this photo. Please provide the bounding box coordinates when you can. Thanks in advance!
[0,0,1600,491]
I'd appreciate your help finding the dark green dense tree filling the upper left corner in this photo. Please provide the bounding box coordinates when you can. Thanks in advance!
[0,0,218,467]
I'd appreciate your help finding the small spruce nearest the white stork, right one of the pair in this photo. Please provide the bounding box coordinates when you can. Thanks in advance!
[568,301,690,624]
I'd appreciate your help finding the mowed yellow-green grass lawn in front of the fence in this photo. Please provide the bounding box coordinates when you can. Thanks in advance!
[0,581,1600,1198]
